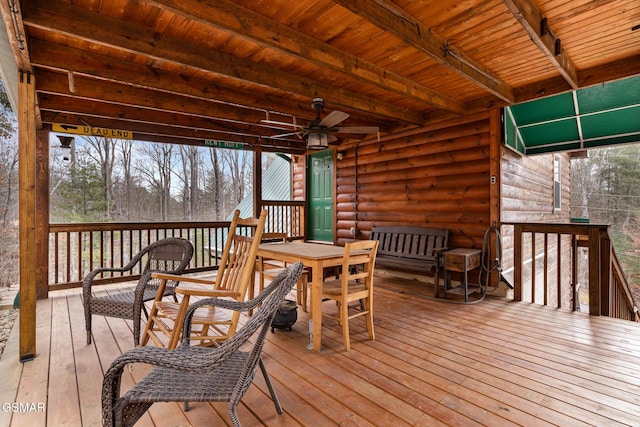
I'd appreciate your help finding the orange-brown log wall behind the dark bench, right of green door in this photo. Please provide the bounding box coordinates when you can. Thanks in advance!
[336,113,489,248]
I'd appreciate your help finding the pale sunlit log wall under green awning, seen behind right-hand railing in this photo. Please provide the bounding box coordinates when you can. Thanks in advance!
[500,148,571,307]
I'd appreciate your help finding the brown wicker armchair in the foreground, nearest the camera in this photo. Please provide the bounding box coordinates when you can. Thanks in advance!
[102,263,302,426]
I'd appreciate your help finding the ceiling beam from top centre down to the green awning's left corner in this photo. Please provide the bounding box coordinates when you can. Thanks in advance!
[333,0,514,103]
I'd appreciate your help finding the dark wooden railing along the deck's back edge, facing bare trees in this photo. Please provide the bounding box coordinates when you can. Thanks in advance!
[48,201,304,290]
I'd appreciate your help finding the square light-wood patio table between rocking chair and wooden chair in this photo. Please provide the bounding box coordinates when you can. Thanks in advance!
[258,242,352,352]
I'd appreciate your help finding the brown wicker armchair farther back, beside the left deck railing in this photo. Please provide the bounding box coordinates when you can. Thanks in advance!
[82,237,193,345]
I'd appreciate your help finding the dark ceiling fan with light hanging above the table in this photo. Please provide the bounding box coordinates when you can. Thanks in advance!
[263,98,378,150]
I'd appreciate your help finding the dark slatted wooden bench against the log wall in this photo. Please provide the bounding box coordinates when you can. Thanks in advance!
[371,226,449,292]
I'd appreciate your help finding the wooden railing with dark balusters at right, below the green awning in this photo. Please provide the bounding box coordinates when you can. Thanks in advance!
[503,223,640,321]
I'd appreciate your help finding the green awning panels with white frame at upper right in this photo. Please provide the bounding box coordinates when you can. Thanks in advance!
[504,76,640,155]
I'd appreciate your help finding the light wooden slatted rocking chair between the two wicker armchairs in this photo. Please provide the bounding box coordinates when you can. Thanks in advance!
[141,210,267,349]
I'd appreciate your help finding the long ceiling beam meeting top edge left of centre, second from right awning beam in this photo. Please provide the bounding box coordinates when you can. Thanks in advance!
[147,0,464,114]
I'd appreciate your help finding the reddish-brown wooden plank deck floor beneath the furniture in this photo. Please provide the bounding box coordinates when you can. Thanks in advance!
[0,278,640,427]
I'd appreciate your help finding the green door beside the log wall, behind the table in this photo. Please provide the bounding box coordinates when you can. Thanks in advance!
[307,150,333,242]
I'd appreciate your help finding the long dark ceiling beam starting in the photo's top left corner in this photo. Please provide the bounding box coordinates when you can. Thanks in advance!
[23,0,424,124]
